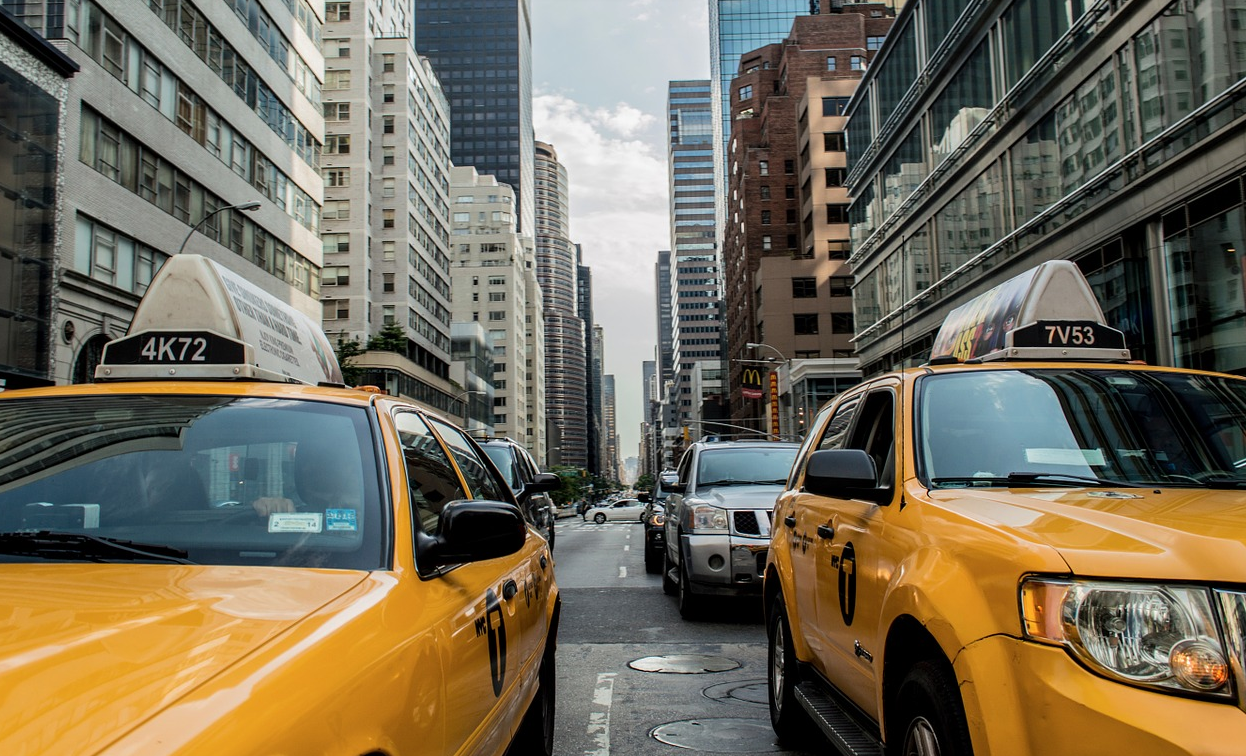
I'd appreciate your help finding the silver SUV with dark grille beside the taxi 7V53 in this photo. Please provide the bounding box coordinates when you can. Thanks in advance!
[662,441,799,619]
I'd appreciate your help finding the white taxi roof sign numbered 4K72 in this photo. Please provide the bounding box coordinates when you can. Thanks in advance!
[95,254,343,385]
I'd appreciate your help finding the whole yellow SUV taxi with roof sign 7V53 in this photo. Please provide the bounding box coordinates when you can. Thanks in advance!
[765,262,1246,756]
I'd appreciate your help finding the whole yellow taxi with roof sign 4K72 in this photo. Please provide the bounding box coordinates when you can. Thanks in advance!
[0,255,559,756]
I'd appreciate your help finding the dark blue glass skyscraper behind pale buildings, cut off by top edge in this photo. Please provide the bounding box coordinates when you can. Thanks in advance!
[414,0,535,235]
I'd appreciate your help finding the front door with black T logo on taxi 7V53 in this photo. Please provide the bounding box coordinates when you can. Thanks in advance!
[810,381,897,717]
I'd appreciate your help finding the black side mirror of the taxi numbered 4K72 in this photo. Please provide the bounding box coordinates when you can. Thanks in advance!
[415,500,520,572]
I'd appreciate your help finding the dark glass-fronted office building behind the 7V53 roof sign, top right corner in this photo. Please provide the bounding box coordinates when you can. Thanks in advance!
[847,0,1246,375]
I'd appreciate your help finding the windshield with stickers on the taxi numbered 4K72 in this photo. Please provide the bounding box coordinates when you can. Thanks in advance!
[0,395,389,569]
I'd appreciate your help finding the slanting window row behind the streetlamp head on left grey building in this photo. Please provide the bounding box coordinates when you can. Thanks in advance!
[78,106,320,296]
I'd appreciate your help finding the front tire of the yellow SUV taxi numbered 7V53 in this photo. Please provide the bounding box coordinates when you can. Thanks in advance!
[887,660,973,756]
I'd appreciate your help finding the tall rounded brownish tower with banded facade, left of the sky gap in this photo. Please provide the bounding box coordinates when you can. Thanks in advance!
[533,142,589,467]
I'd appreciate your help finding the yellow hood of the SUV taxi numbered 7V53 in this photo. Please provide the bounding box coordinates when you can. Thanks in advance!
[930,488,1246,583]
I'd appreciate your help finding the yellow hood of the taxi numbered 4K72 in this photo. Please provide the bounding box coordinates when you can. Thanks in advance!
[0,563,368,756]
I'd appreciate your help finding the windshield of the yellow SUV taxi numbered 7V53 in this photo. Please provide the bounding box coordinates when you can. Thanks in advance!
[917,369,1246,487]
